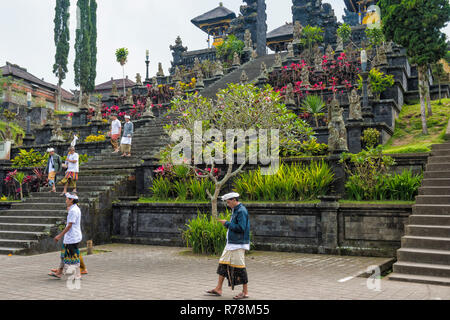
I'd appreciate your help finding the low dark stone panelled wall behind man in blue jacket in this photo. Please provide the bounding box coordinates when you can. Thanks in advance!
[112,202,412,257]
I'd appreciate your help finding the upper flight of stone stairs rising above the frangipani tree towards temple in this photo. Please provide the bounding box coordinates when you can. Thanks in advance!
[200,54,275,99]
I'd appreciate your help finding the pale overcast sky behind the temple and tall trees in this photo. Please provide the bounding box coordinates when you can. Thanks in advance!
[0,0,450,94]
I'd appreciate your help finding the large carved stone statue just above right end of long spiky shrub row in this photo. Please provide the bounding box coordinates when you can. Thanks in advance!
[328,99,348,153]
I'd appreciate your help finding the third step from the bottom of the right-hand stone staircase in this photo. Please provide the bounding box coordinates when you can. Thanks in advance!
[397,248,450,266]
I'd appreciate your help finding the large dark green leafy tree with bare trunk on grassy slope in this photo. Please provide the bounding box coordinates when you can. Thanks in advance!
[378,0,450,134]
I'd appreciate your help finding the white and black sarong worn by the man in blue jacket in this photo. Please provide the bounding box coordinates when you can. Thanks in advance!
[217,249,248,290]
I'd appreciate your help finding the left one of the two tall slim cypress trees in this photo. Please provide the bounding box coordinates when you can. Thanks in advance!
[53,0,70,110]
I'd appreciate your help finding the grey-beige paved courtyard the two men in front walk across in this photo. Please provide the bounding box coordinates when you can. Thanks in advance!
[0,244,450,300]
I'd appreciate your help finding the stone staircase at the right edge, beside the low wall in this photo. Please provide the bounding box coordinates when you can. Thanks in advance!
[389,143,450,285]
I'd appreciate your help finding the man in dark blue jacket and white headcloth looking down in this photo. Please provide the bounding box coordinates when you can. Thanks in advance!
[206,192,250,299]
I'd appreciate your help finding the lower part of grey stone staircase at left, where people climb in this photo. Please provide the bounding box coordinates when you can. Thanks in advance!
[0,119,168,254]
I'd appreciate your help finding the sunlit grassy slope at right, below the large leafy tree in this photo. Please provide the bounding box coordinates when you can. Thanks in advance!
[383,99,450,153]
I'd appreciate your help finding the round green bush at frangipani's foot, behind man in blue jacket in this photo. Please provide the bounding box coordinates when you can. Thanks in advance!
[182,211,231,255]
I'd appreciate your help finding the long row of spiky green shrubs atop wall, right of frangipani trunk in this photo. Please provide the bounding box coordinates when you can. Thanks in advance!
[234,161,334,201]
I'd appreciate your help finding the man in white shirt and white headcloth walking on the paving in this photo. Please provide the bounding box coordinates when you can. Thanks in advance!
[49,193,83,280]
